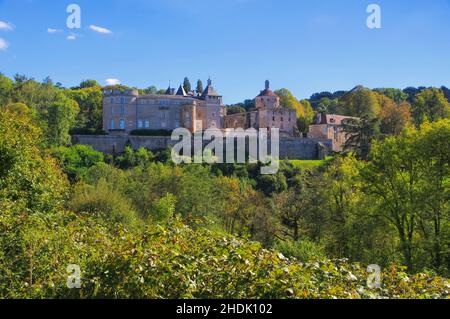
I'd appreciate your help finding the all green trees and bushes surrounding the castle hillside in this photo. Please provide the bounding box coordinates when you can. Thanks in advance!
[0,76,450,298]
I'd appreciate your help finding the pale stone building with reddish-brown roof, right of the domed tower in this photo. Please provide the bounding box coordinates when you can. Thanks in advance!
[308,113,356,152]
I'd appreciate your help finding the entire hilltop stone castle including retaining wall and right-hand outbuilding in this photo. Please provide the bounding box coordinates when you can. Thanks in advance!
[72,80,356,160]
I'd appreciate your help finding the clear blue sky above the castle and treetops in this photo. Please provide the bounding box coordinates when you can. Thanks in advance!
[0,0,450,103]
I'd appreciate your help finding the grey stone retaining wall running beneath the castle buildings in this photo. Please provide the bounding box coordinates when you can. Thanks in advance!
[72,135,333,160]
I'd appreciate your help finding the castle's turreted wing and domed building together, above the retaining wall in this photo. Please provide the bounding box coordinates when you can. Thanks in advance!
[103,79,298,137]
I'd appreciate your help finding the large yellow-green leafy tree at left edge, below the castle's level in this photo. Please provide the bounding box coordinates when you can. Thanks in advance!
[0,110,67,214]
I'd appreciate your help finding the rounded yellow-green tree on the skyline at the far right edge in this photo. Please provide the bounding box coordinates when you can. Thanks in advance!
[412,88,450,127]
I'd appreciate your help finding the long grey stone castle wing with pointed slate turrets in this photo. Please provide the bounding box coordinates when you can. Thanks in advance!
[103,80,225,134]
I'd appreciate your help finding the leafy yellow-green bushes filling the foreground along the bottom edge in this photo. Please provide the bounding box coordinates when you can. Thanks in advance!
[0,207,450,299]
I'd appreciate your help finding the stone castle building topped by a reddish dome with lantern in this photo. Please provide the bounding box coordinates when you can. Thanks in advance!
[225,81,298,137]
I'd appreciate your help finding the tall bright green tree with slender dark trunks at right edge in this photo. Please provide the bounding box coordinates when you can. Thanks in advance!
[361,120,450,271]
